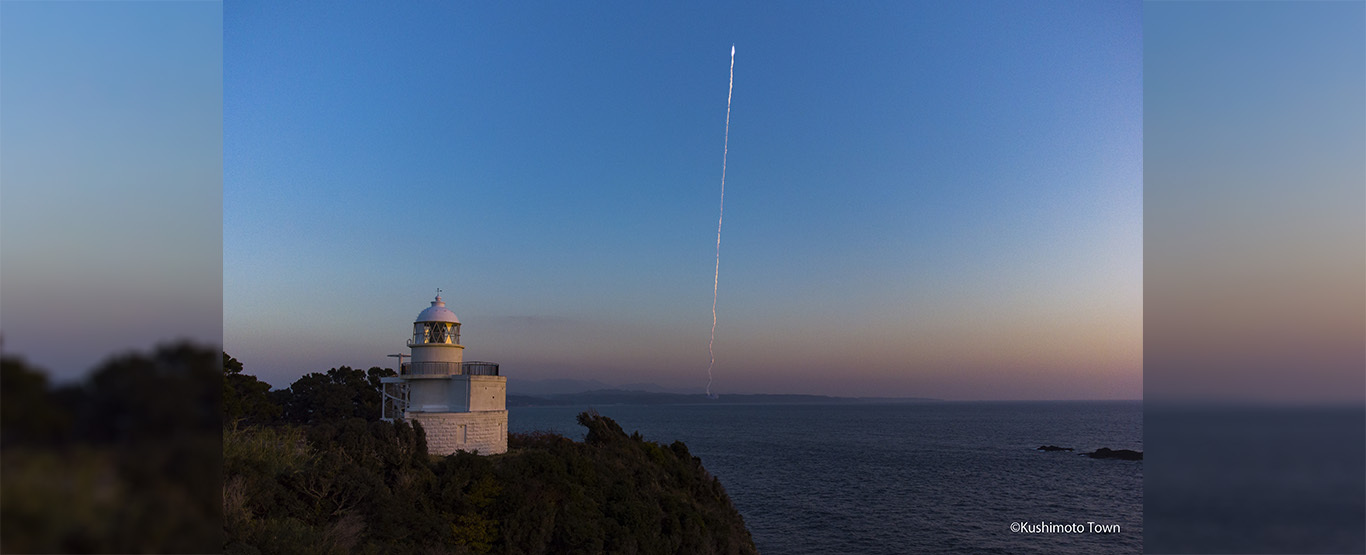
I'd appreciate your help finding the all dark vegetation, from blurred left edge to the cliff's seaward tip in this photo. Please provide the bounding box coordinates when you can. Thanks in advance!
[0,348,754,554]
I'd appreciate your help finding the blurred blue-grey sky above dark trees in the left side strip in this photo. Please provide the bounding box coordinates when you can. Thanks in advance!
[0,1,223,380]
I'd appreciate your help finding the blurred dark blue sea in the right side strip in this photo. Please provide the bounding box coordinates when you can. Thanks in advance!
[1143,403,1366,554]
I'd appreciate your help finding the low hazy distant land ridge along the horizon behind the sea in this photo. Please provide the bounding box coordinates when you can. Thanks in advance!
[507,388,943,406]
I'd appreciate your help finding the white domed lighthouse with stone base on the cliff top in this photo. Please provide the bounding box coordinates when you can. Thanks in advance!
[381,290,508,455]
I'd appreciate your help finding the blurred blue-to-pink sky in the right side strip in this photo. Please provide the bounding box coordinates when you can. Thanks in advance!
[1143,1,1366,406]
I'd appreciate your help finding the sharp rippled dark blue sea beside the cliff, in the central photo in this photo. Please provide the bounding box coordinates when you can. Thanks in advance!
[508,401,1143,554]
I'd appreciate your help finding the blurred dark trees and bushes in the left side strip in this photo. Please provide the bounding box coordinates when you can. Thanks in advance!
[0,343,223,554]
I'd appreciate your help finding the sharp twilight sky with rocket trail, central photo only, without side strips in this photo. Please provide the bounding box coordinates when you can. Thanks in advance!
[223,1,1143,399]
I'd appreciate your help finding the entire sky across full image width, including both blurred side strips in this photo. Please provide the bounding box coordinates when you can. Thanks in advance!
[0,1,1366,403]
